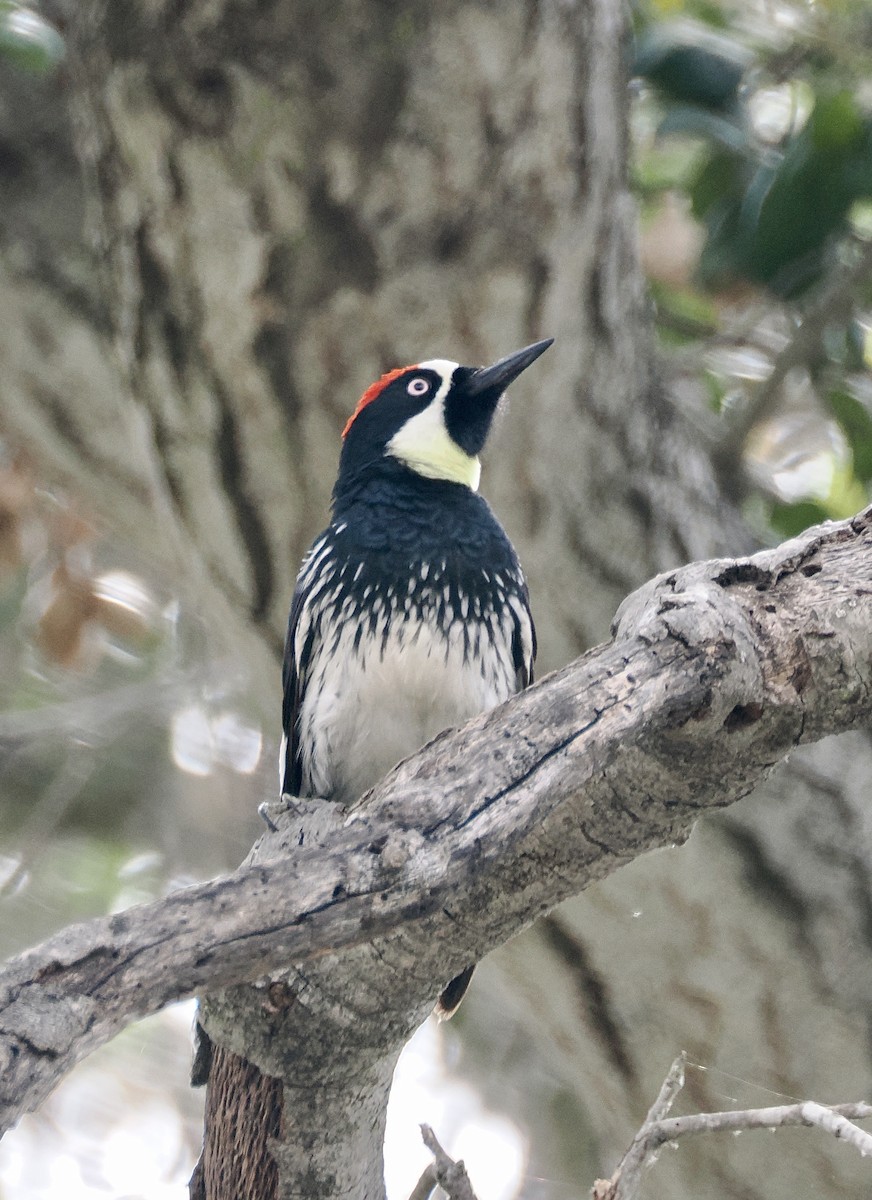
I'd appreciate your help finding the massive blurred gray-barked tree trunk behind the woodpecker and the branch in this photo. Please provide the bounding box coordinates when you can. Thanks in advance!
[0,0,872,1198]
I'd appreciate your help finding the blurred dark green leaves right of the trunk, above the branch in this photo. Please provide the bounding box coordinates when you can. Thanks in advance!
[632,0,872,535]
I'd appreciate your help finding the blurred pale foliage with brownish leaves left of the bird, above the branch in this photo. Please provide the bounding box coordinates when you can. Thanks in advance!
[0,443,266,940]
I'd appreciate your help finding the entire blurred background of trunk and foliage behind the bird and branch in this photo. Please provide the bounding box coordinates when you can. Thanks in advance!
[0,0,872,1200]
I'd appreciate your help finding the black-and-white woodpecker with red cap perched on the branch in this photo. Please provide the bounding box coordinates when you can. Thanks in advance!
[281,338,553,1013]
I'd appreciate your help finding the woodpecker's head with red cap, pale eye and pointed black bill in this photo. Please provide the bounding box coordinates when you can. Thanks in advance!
[337,337,554,492]
